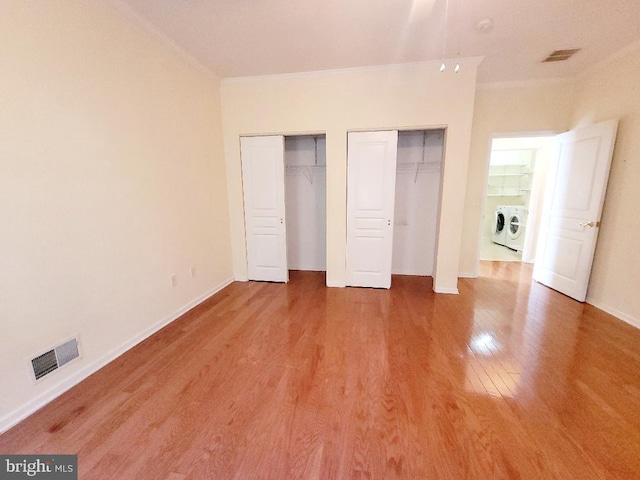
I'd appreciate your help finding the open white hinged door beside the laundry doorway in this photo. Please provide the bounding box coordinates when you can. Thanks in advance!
[533,120,618,302]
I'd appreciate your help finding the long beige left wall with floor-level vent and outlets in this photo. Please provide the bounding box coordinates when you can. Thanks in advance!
[0,0,233,431]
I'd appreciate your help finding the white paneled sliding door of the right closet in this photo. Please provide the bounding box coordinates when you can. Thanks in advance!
[346,131,398,288]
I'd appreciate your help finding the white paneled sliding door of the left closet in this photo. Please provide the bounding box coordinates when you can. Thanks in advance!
[240,135,289,282]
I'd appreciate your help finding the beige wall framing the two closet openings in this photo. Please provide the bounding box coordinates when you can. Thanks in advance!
[222,59,477,292]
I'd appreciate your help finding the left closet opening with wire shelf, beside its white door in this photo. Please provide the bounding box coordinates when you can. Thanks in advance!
[284,135,327,272]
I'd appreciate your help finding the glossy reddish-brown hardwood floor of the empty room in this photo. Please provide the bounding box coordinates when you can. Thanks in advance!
[0,262,640,480]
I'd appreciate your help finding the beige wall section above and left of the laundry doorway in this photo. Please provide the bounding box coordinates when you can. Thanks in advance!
[460,83,574,277]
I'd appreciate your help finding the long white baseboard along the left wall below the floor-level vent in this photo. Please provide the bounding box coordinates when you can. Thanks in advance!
[0,278,233,433]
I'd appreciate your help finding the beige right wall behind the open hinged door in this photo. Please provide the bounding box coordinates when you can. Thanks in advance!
[573,45,640,326]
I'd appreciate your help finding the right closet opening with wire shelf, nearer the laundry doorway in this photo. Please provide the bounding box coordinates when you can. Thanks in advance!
[391,129,445,276]
